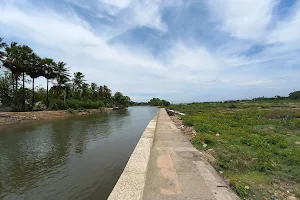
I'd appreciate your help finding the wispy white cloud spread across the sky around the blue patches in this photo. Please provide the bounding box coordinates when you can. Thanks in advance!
[0,0,300,102]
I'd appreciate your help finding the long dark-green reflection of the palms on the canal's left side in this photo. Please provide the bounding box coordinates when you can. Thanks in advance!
[0,110,150,199]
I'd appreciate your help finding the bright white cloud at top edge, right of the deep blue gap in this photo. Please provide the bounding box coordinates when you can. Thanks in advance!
[208,0,276,40]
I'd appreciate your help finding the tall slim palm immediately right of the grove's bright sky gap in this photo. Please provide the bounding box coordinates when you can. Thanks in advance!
[42,58,57,109]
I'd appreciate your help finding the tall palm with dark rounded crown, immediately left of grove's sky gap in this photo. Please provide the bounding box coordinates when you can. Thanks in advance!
[27,54,44,110]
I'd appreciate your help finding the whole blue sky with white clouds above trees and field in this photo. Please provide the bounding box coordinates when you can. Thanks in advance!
[0,0,300,103]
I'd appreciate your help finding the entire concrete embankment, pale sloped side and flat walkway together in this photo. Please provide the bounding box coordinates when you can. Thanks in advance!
[108,109,239,200]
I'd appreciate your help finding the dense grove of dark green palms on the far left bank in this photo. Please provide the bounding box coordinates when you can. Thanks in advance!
[0,38,131,111]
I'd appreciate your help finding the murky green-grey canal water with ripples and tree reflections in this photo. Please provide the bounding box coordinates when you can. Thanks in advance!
[0,107,158,200]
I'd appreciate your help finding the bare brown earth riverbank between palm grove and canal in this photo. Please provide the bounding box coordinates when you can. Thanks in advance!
[0,108,113,126]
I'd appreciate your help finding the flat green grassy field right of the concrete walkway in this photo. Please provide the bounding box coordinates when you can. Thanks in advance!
[171,100,300,199]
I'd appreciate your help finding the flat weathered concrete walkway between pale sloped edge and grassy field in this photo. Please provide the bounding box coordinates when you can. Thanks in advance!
[141,109,239,200]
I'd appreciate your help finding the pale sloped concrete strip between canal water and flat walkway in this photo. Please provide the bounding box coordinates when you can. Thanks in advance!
[108,110,159,200]
